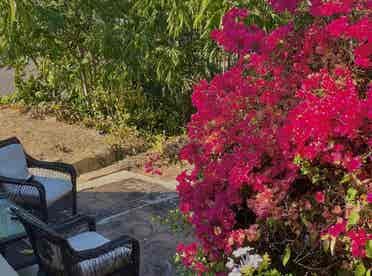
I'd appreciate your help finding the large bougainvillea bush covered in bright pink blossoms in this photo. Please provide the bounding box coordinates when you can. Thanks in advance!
[177,0,372,275]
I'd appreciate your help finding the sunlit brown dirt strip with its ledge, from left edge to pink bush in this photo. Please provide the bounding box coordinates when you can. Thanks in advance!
[0,106,185,181]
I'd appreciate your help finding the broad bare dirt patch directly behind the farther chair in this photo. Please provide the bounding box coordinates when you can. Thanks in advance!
[0,107,110,171]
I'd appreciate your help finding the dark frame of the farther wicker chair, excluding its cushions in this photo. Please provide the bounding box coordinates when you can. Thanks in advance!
[0,137,77,221]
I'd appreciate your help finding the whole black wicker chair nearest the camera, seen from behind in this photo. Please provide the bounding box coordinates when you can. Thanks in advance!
[12,208,140,276]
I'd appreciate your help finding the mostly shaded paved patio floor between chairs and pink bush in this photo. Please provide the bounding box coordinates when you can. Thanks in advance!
[78,179,191,276]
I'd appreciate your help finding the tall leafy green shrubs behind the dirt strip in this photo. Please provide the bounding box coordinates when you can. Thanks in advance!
[0,0,232,135]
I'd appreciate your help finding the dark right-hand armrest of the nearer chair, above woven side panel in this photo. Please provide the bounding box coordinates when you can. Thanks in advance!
[71,235,139,262]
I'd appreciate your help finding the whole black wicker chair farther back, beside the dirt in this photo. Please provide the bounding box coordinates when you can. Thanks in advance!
[0,137,77,221]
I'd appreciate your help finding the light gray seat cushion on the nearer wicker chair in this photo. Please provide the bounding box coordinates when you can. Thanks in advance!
[68,232,110,251]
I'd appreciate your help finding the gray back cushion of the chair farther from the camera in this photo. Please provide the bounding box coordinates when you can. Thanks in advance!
[0,144,30,179]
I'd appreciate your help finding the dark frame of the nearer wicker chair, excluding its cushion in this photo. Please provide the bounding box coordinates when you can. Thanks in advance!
[12,208,140,276]
